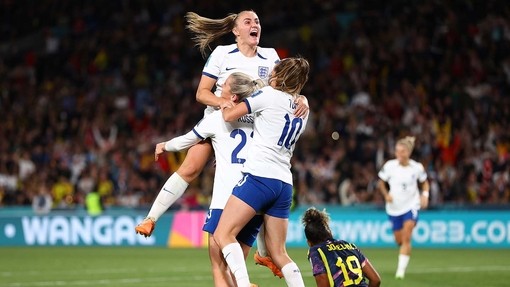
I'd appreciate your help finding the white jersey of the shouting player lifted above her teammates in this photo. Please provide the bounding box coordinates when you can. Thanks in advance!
[202,44,280,114]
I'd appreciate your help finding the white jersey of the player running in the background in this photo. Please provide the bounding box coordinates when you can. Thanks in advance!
[378,159,427,216]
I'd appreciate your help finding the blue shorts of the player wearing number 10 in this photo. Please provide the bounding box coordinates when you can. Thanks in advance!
[232,173,292,218]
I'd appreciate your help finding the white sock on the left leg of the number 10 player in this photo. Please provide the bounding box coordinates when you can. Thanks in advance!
[221,242,250,287]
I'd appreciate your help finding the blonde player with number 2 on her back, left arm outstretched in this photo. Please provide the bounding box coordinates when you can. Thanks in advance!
[154,72,265,287]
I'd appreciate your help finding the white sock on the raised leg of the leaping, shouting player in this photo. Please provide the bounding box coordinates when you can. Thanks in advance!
[147,172,189,221]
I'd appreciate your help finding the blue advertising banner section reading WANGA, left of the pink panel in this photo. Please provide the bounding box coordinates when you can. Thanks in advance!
[0,215,171,246]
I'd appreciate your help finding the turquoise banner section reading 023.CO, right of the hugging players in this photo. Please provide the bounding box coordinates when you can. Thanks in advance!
[287,208,510,248]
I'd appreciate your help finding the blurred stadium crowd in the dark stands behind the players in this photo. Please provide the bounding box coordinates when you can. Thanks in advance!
[0,0,510,212]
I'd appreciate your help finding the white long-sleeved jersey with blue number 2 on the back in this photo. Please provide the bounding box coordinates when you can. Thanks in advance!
[165,110,253,209]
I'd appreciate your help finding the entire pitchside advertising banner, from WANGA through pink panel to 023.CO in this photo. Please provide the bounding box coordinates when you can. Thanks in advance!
[0,207,510,248]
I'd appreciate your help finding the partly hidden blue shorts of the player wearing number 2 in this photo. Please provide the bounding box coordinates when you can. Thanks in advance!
[202,209,264,247]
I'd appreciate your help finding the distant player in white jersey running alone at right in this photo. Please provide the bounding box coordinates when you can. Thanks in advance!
[378,136,429,279]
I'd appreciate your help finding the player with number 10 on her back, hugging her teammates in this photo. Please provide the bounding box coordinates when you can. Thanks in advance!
[214,58,310,287]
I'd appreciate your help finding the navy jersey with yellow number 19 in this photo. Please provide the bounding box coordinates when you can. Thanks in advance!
[308,239,368,287]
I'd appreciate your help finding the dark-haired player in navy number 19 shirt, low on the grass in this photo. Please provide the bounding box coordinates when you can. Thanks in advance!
[302,207,381,287]
